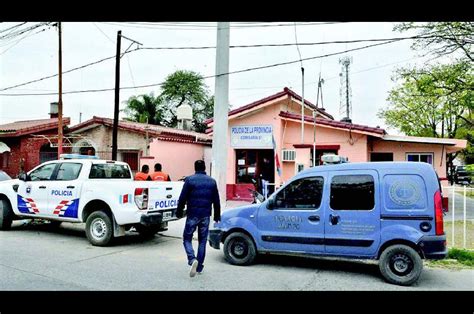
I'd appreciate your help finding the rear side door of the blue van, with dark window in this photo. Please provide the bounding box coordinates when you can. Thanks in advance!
[324,170,380,256]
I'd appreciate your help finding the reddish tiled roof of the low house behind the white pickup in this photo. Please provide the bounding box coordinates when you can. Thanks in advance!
[69,116,212,143]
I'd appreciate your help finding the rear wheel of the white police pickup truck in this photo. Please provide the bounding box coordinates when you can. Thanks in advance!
[86,211,114,246]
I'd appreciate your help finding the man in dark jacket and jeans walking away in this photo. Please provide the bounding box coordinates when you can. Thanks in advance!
[176,160,221,277]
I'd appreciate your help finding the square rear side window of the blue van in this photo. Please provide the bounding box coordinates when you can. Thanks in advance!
[330,175,375,210]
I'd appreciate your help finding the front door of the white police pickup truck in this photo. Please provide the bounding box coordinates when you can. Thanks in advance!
[17,163,58,216]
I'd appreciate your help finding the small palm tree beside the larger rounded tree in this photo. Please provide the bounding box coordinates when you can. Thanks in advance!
[123,93,164,125]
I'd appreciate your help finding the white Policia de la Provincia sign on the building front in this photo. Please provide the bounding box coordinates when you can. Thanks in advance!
[230,125,273,148]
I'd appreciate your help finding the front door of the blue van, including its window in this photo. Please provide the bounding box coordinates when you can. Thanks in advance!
[257,174,325,253]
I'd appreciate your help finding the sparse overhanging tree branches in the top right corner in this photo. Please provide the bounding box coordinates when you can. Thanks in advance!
[395,22,474,62]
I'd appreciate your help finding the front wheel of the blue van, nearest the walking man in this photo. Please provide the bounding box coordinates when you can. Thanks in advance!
[224,232,257,265]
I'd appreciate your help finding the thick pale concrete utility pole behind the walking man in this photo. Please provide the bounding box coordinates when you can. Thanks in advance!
[211,22,230,208]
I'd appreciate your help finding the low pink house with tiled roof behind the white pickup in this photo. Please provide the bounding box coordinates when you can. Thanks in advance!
[68,116,212,180]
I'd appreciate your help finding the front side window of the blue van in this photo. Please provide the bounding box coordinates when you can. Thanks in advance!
[275,177,324,209]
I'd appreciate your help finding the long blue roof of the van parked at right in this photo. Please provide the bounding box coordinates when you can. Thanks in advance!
[299,161,434,174]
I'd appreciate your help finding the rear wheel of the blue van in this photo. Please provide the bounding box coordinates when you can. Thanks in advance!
[379,244,423,286]
